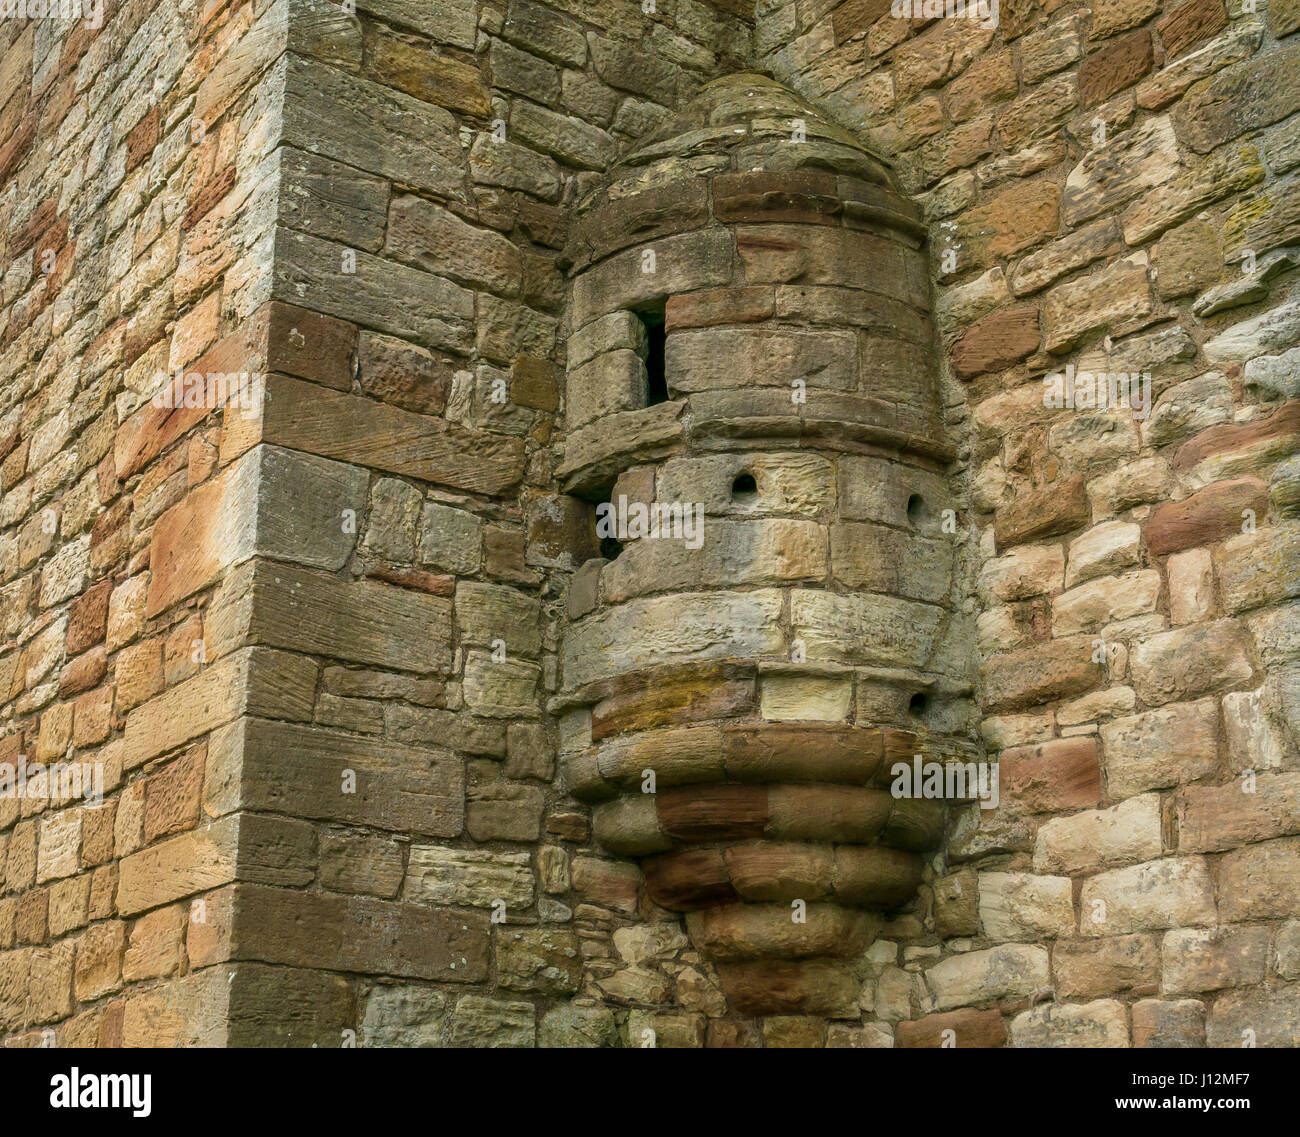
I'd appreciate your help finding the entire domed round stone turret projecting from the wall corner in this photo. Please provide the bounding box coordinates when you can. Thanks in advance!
[554,74,978,1015]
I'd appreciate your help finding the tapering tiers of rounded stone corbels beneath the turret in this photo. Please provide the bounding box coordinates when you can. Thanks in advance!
[566,722,972,1015]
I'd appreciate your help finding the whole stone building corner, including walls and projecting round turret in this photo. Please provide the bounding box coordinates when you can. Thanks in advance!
[0,0,1300,1047]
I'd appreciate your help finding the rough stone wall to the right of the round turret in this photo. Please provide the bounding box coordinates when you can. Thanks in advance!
[755,0,1300,1046]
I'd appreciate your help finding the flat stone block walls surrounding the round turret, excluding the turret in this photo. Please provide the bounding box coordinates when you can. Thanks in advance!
[0,0,1300,1046]
